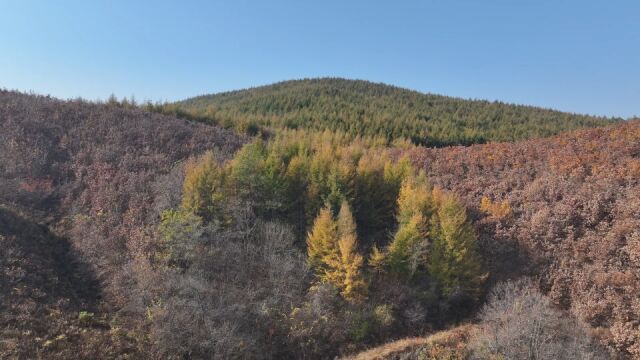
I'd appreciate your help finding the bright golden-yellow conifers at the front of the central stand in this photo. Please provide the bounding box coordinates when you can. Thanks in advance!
[307,169,486,302]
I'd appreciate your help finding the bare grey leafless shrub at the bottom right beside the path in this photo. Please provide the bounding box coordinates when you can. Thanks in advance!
[471,281,608,360]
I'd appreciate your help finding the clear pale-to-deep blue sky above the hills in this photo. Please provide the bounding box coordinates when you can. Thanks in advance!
[0,0,640,117]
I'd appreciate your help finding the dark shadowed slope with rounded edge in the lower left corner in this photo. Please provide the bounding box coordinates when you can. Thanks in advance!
[0,207,129,359]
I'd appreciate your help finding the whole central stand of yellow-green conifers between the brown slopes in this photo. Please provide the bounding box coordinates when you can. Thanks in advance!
[161,130,484,318]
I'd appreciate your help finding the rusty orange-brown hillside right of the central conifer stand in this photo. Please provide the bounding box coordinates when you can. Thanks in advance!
[409,121,640,358]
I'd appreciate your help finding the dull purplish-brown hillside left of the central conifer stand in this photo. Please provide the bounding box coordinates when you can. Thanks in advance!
[0,91,245,359]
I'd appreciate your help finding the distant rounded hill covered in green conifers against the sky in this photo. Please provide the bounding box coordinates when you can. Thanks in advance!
[175,78,620,146]
